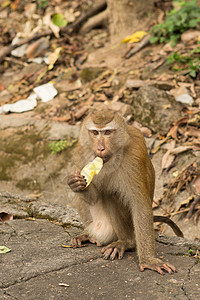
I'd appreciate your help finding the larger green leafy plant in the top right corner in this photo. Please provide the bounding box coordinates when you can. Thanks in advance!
[150,0,200,46]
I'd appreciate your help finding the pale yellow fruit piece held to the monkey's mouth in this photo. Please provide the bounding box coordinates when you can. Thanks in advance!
[81,156,103,187]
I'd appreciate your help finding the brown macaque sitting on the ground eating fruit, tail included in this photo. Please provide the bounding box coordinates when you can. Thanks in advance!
[68,109,182,274]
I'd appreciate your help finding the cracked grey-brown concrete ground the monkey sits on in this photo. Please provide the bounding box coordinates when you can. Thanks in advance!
[0,218,200,300]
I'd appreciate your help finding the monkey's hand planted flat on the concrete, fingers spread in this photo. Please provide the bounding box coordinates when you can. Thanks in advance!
[140,258,176,275]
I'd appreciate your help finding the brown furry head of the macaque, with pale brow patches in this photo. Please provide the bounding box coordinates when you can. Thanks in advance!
[79,110,130,163]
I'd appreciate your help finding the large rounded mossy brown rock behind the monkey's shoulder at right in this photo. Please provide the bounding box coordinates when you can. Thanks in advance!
[133,86,181,132]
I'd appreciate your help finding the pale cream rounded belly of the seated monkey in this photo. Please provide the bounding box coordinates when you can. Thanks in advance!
[87,203,117,245]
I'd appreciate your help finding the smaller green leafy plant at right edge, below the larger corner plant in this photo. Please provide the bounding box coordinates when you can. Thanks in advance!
[167,47,200,78]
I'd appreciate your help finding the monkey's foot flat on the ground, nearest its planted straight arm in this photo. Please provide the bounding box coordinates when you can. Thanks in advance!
[101,241,126,260]
